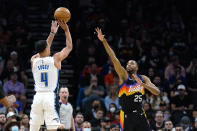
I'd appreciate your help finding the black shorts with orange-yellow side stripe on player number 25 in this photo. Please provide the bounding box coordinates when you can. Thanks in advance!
[120,110,150,131]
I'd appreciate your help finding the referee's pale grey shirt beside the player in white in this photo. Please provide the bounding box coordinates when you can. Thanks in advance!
[60,102,73,129]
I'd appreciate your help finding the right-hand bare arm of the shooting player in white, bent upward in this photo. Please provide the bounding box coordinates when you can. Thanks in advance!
[54,21,73,67]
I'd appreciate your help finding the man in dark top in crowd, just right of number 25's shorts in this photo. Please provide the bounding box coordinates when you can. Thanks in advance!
[151,111,164,131]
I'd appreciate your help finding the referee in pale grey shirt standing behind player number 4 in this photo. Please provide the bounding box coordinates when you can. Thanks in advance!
[59,87,74,130]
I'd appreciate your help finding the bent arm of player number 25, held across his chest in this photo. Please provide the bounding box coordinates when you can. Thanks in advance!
[132,74,160,95]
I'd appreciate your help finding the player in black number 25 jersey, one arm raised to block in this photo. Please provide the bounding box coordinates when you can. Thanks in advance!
[96,28,160,131]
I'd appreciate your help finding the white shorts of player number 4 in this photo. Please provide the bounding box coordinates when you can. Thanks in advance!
[30,92,60,130]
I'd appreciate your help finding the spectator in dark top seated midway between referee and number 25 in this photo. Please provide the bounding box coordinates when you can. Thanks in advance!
[82,77,105,109]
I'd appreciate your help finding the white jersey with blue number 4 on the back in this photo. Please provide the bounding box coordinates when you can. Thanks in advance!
[32,56,59,92]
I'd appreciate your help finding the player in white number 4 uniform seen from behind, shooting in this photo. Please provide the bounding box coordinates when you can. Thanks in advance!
[30,21,72,131]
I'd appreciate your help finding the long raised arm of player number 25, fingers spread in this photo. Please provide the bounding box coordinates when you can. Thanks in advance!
[96,28,128,83]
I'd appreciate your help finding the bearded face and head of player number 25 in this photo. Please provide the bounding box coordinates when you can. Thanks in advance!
[126,60,138,74]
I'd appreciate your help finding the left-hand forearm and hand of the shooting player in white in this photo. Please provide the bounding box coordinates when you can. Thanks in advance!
[47,20,59,47]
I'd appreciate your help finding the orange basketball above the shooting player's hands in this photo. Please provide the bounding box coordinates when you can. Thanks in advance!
[54,7,71,22]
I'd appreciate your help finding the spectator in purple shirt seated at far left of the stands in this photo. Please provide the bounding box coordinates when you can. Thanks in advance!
[3,72,26,112]
